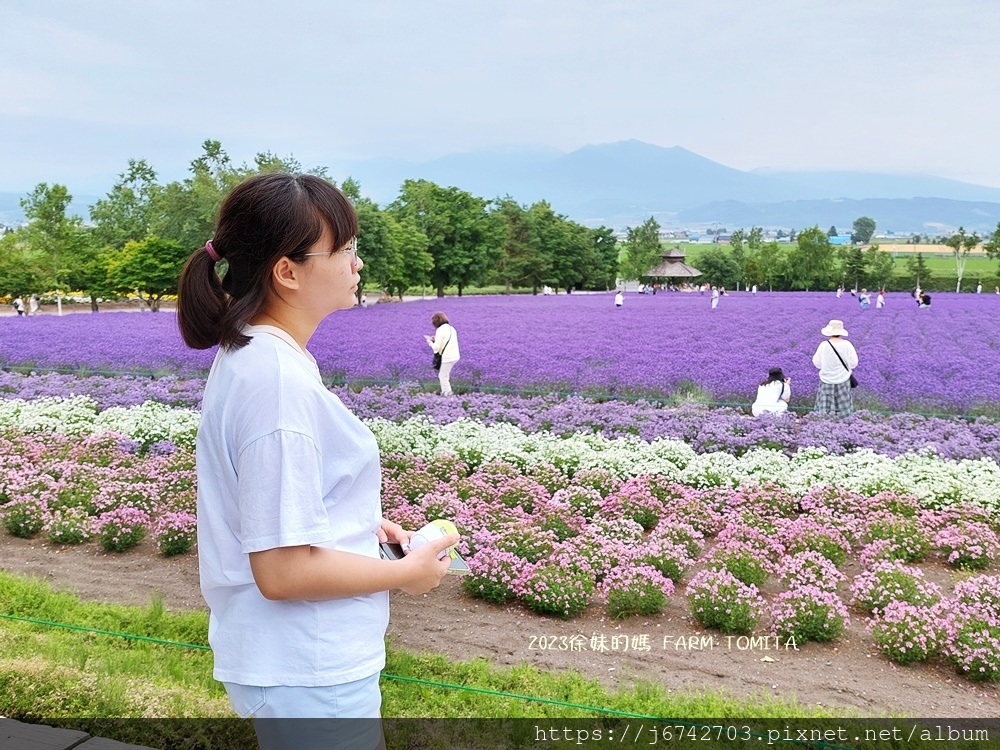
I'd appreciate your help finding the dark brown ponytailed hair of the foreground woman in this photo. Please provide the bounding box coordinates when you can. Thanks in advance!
[177,173,358,349]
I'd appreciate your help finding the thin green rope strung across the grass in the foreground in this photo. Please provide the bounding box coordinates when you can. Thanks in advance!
[0,614,852,750]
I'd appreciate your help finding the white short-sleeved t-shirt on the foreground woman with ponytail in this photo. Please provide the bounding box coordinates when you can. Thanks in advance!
[197,326,389,686]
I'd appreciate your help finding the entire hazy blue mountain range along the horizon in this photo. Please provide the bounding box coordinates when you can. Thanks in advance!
[0,140,1000,234]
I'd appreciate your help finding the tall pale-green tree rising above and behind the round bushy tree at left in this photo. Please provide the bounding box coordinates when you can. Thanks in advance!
[90,159,163,249]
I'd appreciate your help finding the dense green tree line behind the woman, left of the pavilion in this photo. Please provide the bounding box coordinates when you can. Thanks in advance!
[0,140,618,310]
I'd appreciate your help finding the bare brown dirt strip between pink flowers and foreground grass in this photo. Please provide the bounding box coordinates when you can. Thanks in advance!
[0,534,1000,718]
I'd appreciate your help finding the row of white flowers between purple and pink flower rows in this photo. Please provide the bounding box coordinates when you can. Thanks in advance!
[0,396,1000,515]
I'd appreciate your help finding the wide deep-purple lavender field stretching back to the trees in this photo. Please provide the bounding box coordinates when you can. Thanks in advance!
[0,293,1000,414]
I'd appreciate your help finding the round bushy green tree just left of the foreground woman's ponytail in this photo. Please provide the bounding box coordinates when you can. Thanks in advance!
[108,235,190,312]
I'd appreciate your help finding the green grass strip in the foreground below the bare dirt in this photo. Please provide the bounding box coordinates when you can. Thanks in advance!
[0,572,848,721]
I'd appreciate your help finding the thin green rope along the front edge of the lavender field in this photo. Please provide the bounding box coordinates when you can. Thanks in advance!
[0,365,998,422]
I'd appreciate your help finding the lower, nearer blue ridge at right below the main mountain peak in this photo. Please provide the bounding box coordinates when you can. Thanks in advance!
[675,198,1000,235]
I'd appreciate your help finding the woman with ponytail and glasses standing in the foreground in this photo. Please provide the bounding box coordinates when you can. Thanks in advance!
[177,173,458,750]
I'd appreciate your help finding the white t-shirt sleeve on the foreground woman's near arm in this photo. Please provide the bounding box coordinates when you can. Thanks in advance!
[236,430,330,554]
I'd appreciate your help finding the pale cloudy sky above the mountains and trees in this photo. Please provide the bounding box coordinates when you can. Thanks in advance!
[0,0,1000,194]
